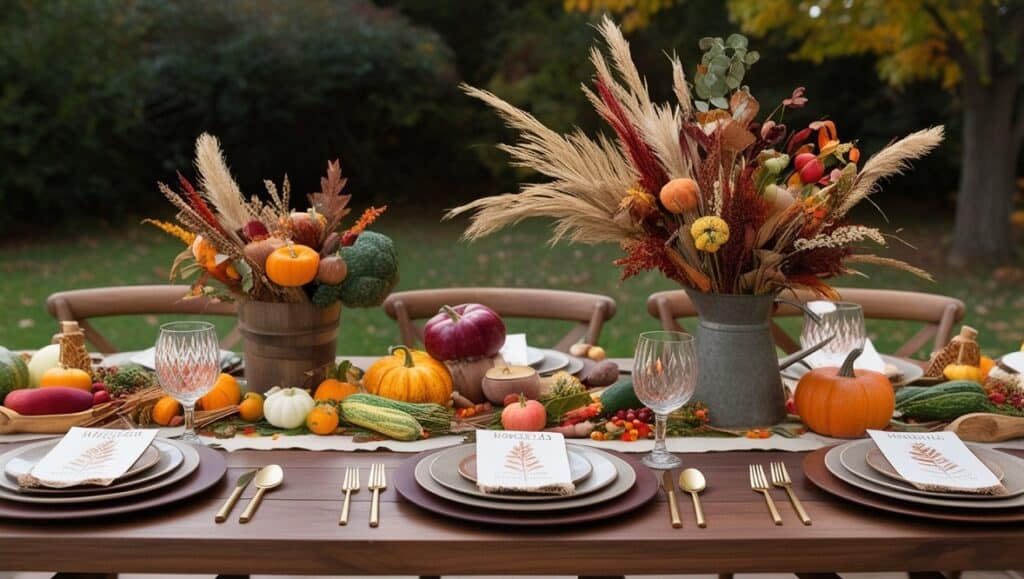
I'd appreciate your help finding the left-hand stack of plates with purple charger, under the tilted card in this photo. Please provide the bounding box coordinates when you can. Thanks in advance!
[0,439,226,519]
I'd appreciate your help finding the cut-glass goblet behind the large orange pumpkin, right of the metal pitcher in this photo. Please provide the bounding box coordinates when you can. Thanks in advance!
[800,301,867,366]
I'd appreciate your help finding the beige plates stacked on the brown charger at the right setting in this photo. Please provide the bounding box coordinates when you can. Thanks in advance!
[825,440,1024,509]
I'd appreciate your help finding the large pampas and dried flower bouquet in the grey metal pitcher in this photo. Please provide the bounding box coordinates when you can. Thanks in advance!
[445,17,943,297]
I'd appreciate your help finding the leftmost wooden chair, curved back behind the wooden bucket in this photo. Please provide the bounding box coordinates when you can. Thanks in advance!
[46,285,242,354]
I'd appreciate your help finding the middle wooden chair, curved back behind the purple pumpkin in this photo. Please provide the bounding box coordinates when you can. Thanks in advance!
[384,287,615,351]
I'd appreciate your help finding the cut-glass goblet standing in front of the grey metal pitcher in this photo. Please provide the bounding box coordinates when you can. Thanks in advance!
[633,331,697,468]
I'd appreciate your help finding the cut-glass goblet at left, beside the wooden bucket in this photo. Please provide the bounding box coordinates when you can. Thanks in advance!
[156,322,220,444]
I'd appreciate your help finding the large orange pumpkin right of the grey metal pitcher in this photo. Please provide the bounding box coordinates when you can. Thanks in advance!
[794,349,896,439]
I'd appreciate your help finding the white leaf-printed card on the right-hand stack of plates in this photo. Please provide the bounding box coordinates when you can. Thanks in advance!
[867,430,1006,494]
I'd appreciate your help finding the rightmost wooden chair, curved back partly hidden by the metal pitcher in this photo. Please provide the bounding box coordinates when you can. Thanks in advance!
[647,288,967,358]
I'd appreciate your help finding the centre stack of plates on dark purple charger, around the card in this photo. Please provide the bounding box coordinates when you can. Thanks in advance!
[395,445,657,525]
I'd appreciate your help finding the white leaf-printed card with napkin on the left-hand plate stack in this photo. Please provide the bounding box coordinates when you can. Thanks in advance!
[17,426,157,489]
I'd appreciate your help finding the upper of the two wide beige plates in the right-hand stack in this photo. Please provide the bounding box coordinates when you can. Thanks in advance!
[839,440,1024,501]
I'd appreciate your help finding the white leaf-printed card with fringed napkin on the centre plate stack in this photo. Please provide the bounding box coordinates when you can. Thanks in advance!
[476,430,575,495]
